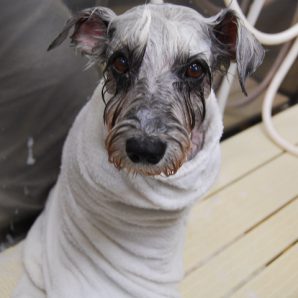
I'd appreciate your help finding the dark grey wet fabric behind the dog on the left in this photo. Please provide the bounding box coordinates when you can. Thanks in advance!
[0,0,98,242]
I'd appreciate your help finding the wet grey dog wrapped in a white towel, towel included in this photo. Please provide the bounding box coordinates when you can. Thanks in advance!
[14,4,264,298]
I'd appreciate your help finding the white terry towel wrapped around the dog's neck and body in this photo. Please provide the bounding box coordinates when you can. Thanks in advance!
[15,82,222,298]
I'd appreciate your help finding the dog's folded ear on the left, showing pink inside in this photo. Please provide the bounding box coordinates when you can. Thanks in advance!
[48,7,116,56]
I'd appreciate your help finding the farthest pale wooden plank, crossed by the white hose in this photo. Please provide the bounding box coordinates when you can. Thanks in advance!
[210,104,298,193]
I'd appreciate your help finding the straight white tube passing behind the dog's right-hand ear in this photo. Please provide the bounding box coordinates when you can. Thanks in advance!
[217,0,265,115]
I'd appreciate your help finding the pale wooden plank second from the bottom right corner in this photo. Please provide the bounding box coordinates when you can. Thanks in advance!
[182,199,298,298]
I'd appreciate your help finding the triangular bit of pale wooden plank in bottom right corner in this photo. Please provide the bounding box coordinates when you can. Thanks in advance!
[231,244,298,298]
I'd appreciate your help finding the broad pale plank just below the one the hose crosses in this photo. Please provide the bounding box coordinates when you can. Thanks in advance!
[185,154,298,271]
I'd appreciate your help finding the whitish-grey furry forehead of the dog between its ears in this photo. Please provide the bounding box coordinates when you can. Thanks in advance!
[110,4,211,60]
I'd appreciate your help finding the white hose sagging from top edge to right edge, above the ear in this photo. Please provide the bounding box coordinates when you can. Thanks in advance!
[224,0,298,45]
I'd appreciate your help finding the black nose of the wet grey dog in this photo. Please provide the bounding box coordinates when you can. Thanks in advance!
[126,137,167,164]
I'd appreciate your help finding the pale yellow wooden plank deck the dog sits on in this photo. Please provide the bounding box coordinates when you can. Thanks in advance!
[0,105,298,298]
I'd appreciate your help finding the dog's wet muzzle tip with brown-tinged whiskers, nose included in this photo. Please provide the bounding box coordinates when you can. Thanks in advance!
[106,121,204,176]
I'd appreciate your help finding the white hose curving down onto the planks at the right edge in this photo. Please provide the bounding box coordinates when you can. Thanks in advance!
[262,38,298,156]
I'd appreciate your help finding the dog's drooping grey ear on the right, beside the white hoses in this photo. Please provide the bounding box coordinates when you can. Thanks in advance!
[212,9,265,94]
